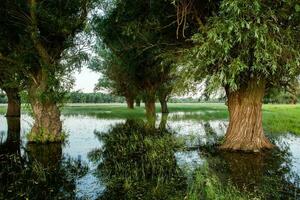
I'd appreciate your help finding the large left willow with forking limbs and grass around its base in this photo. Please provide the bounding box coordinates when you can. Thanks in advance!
[0,0,92,142]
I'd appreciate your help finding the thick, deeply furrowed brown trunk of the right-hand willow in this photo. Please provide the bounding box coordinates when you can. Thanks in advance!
[221,78,273,152]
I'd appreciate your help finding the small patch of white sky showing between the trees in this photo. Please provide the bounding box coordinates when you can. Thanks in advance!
[73,67,100,93]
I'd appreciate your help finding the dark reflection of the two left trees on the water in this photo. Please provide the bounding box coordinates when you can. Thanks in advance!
[0,118,88,199]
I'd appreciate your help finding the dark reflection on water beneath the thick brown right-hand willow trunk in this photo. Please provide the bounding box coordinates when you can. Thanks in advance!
[207,145,300,199]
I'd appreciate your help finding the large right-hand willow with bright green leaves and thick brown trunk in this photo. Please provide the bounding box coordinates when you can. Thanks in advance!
[188,0,300,151]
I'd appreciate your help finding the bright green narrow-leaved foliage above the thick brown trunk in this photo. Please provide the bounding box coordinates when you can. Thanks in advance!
[186,0,300,90]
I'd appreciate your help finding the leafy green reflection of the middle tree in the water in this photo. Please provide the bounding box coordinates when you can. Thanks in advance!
[89,121,185,199]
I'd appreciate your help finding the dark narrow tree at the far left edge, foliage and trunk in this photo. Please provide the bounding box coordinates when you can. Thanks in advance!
[0,0,26,117]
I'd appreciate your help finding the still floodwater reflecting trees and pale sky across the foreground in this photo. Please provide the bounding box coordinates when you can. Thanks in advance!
[0,113,300,199]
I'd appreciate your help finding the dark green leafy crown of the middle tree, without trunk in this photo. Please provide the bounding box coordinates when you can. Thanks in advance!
[91,0,190,103]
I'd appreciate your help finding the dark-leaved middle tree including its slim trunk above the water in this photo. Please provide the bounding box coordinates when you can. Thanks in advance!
[93,0,190,117]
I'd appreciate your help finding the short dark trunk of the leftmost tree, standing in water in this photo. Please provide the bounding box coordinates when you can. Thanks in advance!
[3,88,21,117]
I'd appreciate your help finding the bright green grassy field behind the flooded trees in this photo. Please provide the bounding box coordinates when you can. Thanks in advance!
[0,103,300,135]
